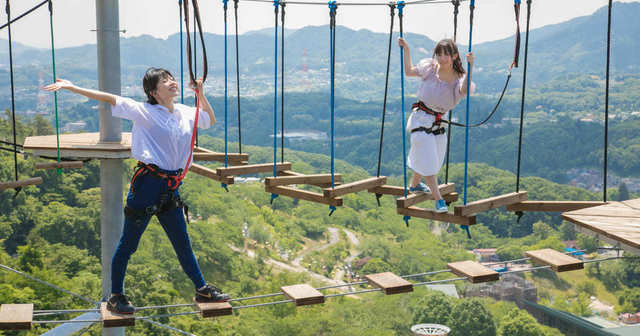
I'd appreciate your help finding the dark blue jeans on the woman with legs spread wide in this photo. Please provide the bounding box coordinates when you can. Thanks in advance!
[111,174,206,294]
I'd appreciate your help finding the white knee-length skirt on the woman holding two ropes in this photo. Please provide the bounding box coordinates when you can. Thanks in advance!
[407,111,447,176]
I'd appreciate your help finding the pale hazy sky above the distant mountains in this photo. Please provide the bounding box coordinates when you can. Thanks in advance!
[0,0,640,48]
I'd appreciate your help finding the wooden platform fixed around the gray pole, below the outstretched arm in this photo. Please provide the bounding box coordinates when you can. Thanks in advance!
[24,132,131,159]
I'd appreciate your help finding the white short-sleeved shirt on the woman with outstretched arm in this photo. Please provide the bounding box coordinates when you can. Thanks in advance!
[111,97,211,170]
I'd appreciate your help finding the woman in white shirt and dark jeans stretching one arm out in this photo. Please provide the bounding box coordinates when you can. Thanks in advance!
[44,68,229,314]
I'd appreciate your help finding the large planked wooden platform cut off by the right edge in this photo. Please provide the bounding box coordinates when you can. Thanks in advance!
[562,199,640,255]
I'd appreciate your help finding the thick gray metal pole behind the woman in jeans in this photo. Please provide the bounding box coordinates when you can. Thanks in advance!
[96,0,124,336]
